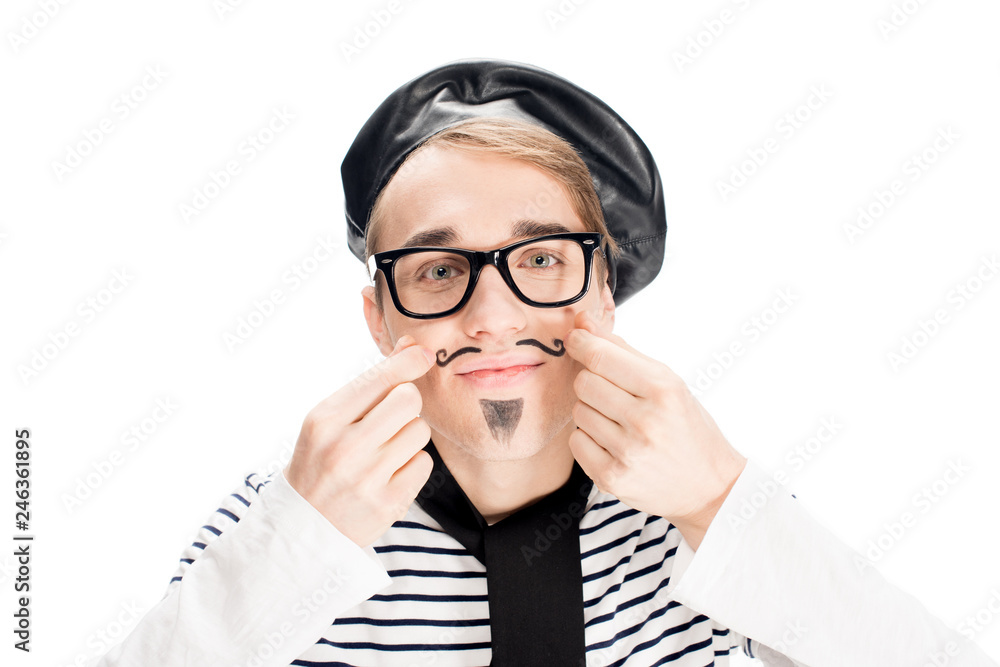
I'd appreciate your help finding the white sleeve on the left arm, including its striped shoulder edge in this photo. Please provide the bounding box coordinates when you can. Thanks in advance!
[96,471,390,667]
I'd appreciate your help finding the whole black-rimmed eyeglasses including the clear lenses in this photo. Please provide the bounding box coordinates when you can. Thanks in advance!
[368,232,603,320]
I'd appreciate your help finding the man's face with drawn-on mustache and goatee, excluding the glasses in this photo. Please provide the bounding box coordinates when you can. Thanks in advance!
[362,146,614,461]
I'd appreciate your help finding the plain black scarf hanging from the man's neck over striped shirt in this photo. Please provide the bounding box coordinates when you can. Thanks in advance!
[416,441,593,667]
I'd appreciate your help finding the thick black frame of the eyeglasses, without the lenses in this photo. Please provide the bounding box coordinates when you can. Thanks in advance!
[367,232,604,320]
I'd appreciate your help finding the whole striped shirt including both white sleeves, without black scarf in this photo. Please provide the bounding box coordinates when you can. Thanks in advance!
[98,460,996,667]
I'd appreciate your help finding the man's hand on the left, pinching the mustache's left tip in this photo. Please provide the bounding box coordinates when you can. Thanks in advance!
[283,335,434,547]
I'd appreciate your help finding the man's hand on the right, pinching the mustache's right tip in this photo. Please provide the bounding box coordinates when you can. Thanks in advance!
[566,312,747,549]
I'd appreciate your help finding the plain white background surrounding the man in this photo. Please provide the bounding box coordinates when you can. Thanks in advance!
[0,0,1000,666]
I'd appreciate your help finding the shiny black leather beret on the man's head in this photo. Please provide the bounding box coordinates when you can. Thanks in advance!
[341,59,667,305]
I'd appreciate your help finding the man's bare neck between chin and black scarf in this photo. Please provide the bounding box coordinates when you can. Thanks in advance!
[432,420,576,524]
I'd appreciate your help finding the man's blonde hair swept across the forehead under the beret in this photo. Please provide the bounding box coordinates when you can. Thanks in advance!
[365,117,621,312]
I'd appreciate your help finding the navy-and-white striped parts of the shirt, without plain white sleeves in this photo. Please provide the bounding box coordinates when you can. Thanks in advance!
[171,473,756,667]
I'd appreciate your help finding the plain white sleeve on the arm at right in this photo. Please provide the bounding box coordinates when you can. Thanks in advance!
[666,460,997,667]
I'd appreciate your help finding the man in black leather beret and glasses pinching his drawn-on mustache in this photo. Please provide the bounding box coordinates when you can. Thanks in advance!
[97,61,994,667]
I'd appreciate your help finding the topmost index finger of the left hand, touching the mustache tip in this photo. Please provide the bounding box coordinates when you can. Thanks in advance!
[330,343,434,422]
